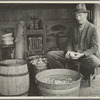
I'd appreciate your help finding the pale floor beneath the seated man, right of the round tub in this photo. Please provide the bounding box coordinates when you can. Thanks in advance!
[80,75,100,97]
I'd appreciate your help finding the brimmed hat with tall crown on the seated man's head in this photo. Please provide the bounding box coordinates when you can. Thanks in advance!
[75,3,90,14]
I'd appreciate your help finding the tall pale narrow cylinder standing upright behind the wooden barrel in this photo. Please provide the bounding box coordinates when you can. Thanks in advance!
[15,21,25,59]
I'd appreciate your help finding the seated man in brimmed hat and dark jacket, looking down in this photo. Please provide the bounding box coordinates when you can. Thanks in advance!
[47,4,100,80]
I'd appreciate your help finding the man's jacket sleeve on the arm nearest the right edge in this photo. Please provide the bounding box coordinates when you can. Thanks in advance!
[84,28,99,56]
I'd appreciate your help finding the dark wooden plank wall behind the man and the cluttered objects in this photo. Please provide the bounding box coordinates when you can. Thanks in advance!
[0,3,92,56]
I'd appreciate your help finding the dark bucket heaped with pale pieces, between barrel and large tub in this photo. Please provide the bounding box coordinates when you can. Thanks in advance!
[27,55,47,95]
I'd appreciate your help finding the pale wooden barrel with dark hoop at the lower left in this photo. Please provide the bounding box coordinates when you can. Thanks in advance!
[0,59,29,96]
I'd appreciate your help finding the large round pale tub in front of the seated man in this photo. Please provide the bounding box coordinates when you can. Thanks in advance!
[36,69,81,96]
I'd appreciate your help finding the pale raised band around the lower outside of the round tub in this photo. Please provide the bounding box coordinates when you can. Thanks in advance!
[38,85,80,94]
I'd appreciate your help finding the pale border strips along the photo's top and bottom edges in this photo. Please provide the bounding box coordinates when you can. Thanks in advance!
[0,0,100,100]
